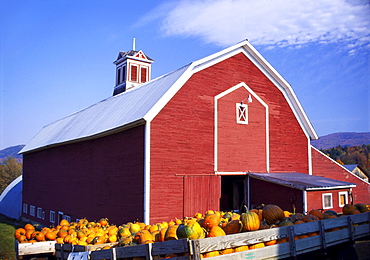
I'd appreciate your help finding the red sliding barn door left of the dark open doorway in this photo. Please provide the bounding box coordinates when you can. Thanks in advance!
[184,175,221,217]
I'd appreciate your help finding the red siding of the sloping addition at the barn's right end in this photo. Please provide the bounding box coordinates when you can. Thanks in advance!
[311,148,370,204]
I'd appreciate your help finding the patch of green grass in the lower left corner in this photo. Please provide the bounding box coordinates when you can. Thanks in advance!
[0,215,28,260]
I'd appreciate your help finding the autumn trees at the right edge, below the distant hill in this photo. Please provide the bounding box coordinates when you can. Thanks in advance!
[320,144,370,176]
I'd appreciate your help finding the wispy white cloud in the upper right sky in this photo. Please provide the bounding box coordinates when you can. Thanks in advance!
[155,0,370,48]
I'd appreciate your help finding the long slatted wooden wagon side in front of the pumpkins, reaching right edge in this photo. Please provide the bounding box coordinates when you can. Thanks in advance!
[90,213,370,260]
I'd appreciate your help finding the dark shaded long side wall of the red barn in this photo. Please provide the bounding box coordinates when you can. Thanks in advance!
[23,126,145,225]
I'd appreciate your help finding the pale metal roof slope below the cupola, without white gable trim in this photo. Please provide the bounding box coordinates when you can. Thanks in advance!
[20,64,190,153]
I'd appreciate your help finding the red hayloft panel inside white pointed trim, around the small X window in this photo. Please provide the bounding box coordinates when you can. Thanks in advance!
[216,87,268,172]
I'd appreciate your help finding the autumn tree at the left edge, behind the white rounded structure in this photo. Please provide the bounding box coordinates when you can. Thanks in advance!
[0,156,22,194]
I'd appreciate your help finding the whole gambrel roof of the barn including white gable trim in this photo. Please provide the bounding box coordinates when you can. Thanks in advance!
[20,40,318,153]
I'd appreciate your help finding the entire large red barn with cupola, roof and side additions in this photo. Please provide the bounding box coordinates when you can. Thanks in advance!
[21,41,370,224]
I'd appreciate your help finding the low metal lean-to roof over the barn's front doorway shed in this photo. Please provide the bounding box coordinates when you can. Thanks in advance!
[248,172,356,190]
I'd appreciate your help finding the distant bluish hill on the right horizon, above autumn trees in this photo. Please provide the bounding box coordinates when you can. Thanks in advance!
[311,132,370,149]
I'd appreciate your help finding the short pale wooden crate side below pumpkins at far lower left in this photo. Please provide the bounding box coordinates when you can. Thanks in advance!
[15,241,55,259]
